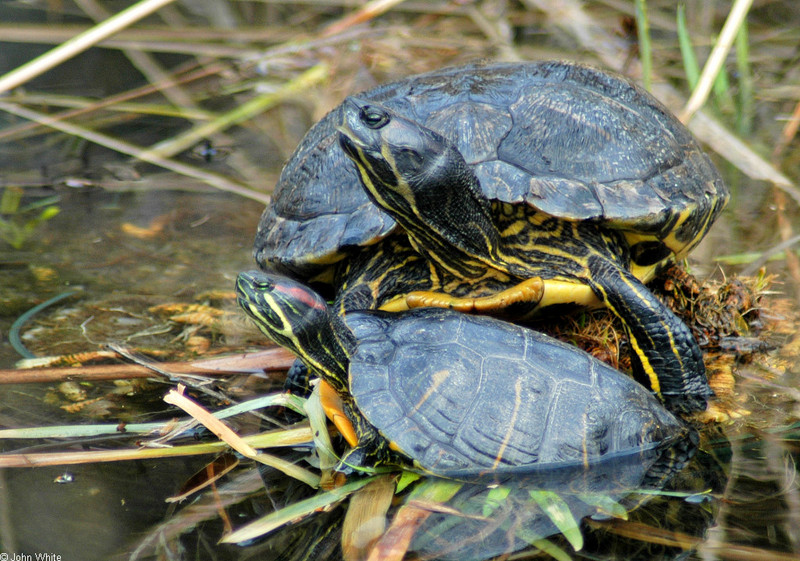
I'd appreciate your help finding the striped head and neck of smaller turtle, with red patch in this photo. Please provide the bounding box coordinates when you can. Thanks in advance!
[236,271,348,390]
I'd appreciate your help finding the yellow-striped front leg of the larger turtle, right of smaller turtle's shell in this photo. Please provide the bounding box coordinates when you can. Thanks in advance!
[585,255,713,413]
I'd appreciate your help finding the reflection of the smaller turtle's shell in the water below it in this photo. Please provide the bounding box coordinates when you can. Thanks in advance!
[409,432,696,561]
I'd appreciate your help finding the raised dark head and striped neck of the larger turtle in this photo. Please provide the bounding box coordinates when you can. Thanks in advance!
[339,97,499,277]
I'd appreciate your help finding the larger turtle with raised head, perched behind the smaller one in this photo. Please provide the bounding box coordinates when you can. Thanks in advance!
[254,62,728,412]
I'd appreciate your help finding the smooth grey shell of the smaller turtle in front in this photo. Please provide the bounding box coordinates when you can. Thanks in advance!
[345,308,683,476]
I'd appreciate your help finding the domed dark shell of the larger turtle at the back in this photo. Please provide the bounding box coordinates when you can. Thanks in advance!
[254,62,728,277]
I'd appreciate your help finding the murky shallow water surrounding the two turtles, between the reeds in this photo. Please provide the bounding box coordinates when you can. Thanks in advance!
[0,2,800,561]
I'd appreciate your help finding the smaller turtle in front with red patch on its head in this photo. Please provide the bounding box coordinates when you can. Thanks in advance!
[236,271,687,478]
